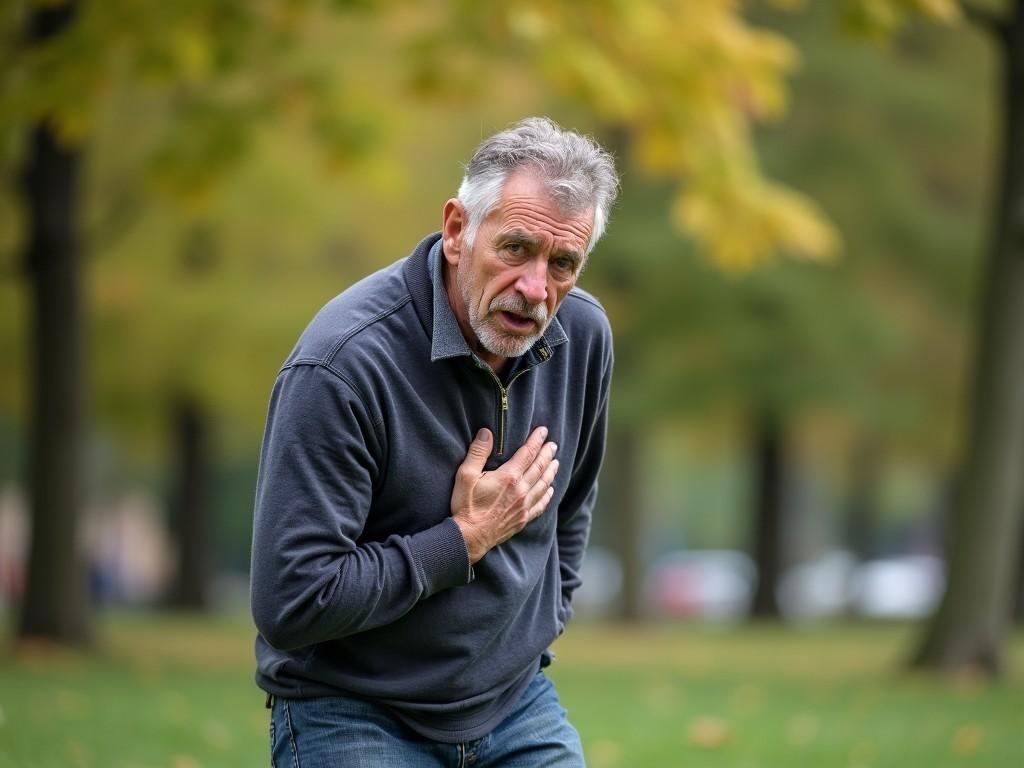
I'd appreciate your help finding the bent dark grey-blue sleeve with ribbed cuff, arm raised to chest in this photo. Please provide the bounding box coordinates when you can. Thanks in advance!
[250,365,472,650]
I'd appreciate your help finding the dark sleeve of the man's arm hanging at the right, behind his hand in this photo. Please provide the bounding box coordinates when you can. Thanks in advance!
[557,331,613,632]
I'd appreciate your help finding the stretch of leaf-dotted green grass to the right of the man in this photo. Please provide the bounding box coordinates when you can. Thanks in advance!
[557,626,1024,768]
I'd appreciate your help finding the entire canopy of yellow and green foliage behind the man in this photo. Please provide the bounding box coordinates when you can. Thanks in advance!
[0,0,989,581]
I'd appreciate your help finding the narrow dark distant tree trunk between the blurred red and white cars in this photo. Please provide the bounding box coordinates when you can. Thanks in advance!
[751,411,785,618]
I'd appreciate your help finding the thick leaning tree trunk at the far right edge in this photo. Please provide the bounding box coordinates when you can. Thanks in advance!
[912,0,1024,676]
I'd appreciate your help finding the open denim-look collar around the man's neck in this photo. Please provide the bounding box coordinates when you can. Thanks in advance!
[404,232,568,369]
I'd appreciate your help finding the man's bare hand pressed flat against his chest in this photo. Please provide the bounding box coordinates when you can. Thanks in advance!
[452,427,558,563]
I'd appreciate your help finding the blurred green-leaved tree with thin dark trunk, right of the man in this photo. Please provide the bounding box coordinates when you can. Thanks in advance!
[584,0,987,622]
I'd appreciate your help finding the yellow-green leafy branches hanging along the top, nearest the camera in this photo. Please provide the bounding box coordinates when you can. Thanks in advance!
[0,0,864,269]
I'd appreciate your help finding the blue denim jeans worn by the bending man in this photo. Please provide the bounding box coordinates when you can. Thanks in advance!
[270,672,584,768]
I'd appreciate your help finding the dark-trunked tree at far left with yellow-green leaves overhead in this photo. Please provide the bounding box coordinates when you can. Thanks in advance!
[0,0,391,643]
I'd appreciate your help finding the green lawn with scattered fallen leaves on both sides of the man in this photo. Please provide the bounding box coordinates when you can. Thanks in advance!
[0,614,1024,768]
